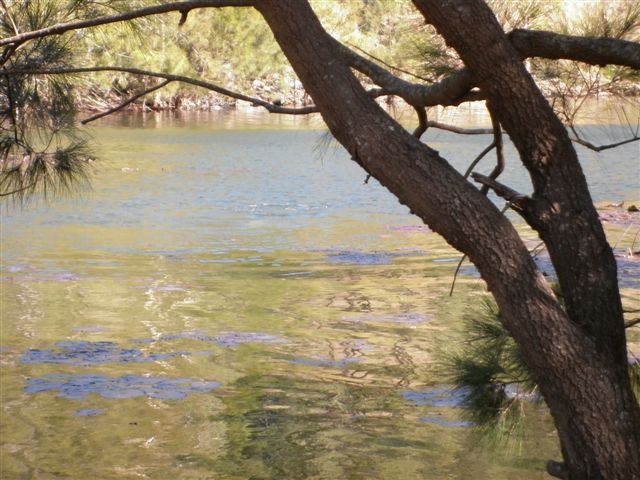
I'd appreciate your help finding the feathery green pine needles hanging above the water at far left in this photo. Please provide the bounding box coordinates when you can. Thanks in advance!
[0,0,101,201]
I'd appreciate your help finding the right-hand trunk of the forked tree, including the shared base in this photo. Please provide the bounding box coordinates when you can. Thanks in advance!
[414,0,640,479]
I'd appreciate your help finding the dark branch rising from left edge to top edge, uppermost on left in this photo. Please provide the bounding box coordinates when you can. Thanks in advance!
[0,0,255,46]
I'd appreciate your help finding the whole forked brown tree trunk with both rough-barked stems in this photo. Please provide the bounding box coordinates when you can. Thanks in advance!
[257,0,640,480]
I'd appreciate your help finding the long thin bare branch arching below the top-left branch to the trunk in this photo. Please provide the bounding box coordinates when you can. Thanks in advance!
[0,66,318,115]
